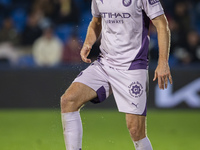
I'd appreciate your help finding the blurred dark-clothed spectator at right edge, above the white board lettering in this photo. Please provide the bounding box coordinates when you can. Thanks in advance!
[174,31,200,64]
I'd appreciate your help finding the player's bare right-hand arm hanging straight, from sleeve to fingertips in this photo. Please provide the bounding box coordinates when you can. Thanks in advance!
[152,15,172,89]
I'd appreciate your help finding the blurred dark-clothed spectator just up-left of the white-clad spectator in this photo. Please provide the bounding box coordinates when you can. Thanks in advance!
[21,12,42,47]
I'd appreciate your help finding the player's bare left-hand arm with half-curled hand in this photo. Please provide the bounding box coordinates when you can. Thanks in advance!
[80,17,101,63]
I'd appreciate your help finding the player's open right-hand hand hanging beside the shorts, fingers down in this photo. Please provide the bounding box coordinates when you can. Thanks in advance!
[153,63,172,90]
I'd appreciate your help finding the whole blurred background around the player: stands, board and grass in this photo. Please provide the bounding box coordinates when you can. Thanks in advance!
[0,0,200,150]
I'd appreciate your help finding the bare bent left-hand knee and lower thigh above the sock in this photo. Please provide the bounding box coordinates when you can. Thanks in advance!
[61,82,97,107]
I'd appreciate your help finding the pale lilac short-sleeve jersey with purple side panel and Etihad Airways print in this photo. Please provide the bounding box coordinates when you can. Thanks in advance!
[92,0,164,70]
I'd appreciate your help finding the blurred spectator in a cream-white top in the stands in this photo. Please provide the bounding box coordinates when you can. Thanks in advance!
[33,27,63,67]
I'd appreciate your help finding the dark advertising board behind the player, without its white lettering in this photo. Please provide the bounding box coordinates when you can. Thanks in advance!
[0,66,200,108]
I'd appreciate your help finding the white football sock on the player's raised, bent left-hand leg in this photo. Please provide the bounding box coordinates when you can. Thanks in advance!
[62,111,83,150]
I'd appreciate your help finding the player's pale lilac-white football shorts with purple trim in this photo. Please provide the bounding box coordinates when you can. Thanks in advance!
[73,61,148,116]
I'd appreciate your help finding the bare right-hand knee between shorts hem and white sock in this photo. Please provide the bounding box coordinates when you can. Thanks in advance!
[126,114,146,141]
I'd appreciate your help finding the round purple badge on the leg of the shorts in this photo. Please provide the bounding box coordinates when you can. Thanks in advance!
[128,81,143,98]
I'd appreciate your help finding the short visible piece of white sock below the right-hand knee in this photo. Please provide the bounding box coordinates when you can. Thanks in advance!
[133,137,153,150]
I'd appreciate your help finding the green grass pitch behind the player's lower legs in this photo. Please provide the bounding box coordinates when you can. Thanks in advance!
[0,109,200,150]
